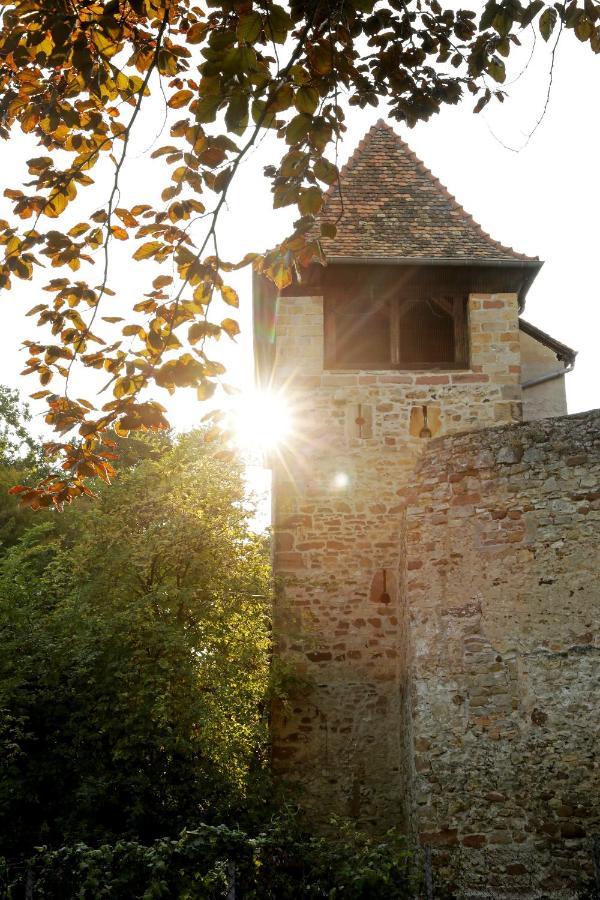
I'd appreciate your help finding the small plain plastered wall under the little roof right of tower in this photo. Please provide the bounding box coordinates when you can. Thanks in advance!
[519,331,567,422]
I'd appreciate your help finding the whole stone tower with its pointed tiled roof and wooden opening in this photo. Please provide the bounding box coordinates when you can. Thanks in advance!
[254,121,600,892]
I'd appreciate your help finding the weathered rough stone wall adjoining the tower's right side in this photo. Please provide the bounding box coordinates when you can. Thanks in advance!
[406,412,600,898]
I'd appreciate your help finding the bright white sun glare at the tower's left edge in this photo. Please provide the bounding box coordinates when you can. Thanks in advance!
[231,390,292,453]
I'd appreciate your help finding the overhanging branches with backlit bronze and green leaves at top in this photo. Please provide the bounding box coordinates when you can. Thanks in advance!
[0,0,600,508]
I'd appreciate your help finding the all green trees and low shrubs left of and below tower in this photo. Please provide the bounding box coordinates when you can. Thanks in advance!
[0,392,422,900]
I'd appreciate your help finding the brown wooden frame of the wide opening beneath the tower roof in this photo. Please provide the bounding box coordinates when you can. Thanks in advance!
[323,291,470,372]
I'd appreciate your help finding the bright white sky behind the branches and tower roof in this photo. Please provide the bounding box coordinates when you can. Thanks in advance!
[0,23,600,468]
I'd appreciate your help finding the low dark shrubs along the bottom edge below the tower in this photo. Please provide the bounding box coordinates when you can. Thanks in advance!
[0,814,417,900]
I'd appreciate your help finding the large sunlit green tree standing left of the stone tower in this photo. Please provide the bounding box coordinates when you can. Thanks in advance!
[0,432,269,858]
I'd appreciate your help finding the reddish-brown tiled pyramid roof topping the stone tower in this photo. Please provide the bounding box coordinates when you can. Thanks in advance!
[321,120,535,263]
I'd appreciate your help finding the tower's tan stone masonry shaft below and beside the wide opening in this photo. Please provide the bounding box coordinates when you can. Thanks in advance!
[273,294,521,830]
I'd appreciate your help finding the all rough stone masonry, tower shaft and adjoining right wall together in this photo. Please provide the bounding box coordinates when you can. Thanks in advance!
[273,286,600,897]
